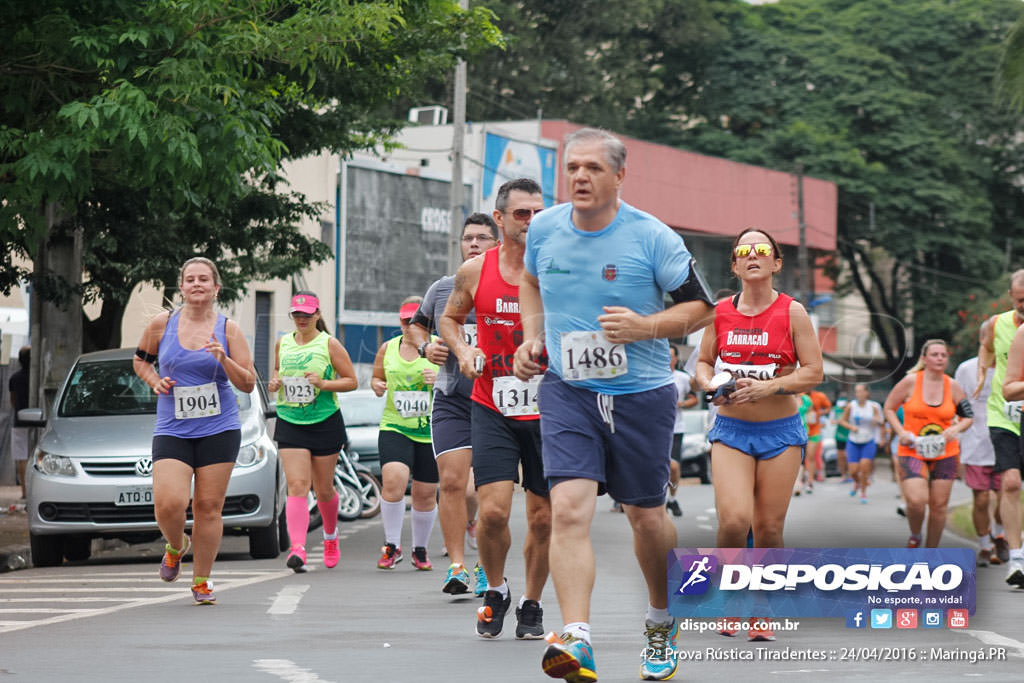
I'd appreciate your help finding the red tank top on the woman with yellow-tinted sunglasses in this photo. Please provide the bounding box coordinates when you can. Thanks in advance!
[715,292,797,380]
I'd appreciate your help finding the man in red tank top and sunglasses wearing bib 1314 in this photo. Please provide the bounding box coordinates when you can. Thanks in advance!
[438,178,551,639]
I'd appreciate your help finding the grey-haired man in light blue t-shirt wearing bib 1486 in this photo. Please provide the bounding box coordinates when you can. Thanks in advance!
[515,128,714,681]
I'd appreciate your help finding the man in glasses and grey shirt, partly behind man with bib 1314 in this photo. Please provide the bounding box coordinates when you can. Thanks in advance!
[410,213,498,597]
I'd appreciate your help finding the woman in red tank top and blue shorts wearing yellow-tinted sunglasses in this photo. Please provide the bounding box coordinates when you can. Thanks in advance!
[696,228,822,640]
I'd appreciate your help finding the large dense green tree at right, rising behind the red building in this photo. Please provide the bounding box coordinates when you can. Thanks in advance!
[676,0,1024,374]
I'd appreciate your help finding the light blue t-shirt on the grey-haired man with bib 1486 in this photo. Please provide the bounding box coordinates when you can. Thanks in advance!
[523,202,691,395]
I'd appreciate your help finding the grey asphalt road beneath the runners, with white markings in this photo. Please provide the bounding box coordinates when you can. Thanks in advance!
[0,462,1024,683]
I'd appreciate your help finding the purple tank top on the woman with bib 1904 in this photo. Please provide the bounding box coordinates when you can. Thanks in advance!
[153,310,242,438]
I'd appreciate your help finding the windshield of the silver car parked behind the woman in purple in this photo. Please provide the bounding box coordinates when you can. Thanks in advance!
[57,358,252,418]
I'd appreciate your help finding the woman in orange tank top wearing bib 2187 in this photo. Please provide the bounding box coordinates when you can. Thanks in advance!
[885,339,974,548]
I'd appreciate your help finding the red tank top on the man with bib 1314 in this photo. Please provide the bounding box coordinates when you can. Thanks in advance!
[471,242,540,420]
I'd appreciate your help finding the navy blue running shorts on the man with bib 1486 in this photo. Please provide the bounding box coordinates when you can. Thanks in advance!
[538,371,676,508]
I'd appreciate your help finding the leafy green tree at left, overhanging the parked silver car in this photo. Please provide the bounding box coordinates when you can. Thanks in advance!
[0,0,498,346]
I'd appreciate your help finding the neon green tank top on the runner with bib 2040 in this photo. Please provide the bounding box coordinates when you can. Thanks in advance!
[381,335,437,443]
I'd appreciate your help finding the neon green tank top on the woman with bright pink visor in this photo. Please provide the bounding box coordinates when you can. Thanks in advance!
[278,332,338,425]
